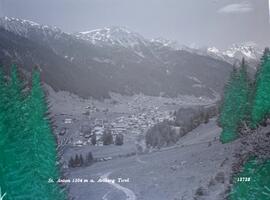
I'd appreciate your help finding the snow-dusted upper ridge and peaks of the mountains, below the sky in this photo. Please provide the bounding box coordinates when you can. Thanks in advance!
[0,17,262,75]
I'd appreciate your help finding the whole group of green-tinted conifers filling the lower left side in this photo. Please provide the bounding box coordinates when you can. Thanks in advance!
[0,66,66,200]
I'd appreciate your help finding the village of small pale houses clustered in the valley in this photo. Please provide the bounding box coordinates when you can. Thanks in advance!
[60,97,176,146]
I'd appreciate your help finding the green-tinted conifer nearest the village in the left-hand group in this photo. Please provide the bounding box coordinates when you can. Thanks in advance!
[24,71,64,200]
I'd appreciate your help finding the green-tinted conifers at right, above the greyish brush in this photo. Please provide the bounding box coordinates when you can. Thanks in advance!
[219,48,270,143]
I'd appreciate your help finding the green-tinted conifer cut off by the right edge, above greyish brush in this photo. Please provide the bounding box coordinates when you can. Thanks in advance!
[251,49,270,127]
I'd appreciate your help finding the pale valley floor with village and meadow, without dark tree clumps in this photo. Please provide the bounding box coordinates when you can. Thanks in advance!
[49,88,238,200]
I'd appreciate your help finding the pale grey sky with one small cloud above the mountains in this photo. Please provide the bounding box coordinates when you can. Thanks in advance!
[0,0,270,48]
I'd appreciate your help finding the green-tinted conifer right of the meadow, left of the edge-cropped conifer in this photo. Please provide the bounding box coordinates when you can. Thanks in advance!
[219,59,250,143]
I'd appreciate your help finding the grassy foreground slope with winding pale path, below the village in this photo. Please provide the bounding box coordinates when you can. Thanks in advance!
[66,120,238,200]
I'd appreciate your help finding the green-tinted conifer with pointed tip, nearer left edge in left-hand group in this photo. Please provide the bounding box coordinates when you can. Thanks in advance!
[1,65,28,200]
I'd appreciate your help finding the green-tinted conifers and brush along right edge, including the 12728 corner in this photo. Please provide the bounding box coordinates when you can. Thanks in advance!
[219,48,270,200]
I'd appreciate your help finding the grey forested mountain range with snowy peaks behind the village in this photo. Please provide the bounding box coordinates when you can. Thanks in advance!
[0,17,252,98]
